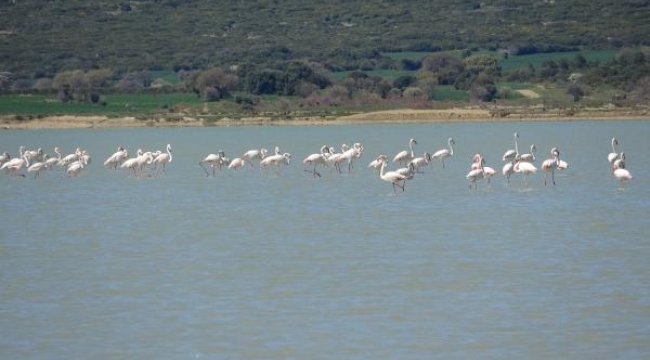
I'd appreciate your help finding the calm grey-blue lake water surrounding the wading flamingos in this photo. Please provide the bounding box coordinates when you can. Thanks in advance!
[0,121,650,360]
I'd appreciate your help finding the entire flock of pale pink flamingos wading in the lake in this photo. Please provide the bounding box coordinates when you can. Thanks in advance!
[0,132,632,192]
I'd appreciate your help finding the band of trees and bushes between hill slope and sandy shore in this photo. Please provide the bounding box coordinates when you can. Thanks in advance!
[0,49,650,105]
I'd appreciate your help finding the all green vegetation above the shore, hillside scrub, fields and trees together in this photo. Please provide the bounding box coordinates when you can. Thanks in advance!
[0,0,650,113]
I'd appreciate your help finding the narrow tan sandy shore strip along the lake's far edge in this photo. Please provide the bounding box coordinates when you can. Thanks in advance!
[0,108,650,130]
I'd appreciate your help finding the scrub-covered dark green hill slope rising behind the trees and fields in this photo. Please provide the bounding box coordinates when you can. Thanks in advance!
[0,0,650,77]
